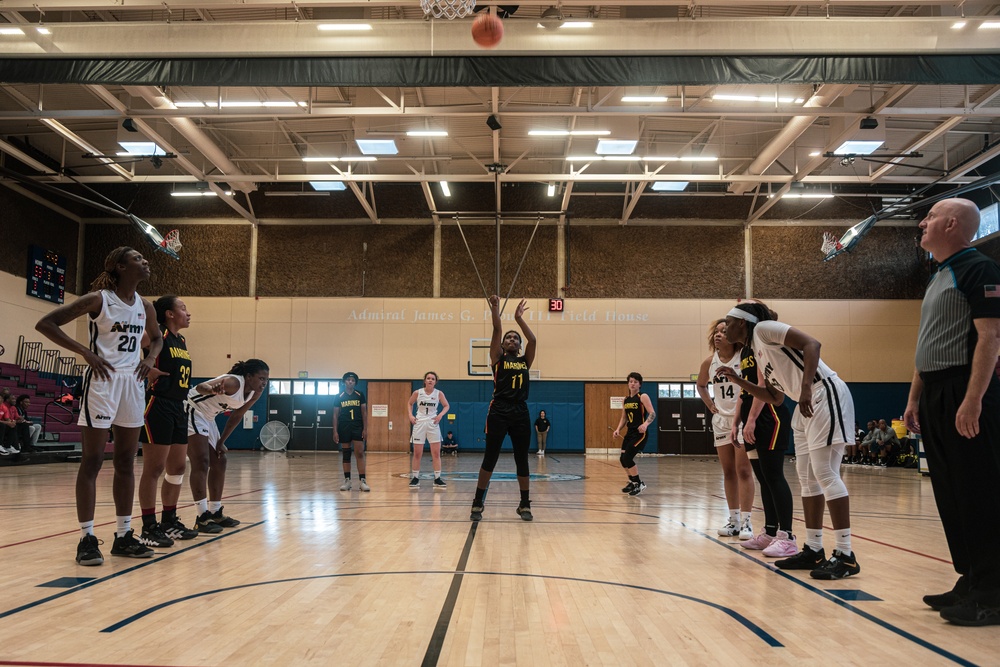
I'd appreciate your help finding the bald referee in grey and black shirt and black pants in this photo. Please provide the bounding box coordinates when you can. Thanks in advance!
[903,199,1000,626]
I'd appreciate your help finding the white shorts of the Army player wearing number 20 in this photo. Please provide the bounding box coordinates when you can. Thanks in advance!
[76,369,146,428]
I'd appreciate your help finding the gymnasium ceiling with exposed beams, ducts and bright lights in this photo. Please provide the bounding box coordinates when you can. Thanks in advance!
[0,0,1000,224]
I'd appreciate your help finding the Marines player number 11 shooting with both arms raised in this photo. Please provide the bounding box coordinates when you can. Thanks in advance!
[470,294,535,521]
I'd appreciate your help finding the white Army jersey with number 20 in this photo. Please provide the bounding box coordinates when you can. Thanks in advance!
[90,290,146,371]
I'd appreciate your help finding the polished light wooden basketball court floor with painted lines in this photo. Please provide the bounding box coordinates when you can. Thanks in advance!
[0,452,988,666]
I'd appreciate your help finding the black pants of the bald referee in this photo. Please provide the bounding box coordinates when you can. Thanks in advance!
[920,368,1000,606]
